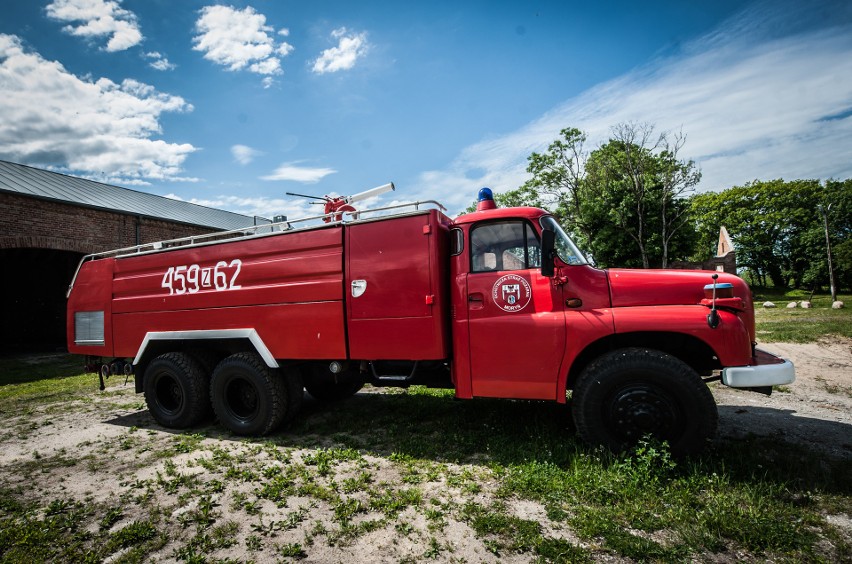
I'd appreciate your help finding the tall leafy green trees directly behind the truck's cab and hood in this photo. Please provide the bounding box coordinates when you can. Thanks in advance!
[498,123,701,268]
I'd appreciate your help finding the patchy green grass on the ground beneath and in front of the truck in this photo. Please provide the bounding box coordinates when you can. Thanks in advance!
[0,334,852,562]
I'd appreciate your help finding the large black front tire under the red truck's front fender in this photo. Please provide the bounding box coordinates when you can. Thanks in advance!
[572,348,719,454]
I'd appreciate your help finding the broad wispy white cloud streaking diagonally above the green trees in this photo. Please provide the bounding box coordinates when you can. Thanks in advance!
[416,3,852,211]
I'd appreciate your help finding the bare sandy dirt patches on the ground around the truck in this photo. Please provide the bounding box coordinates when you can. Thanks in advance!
[0,340,852,562]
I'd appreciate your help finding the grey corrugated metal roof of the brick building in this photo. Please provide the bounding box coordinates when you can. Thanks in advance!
[0,160,262,230]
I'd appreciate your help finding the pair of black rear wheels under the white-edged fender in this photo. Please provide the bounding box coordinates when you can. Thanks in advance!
[143,352,304,435]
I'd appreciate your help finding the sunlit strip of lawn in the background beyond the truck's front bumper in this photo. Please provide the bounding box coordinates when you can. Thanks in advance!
[754,288,852,343]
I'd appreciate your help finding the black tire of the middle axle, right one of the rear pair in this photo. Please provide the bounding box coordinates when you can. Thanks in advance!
[210,353,289,436]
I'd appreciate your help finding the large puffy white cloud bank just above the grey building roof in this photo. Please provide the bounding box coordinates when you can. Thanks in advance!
[0,34,196,184]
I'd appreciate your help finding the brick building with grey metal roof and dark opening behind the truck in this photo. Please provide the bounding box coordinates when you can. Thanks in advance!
[0,161,262,351]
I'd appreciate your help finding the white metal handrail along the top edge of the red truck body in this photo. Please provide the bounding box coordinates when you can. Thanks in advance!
[65,200,447,298]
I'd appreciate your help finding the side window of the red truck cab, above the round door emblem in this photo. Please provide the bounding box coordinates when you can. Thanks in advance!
[470,221,541,272]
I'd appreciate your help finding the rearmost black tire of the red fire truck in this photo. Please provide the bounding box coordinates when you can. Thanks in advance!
[143,352,209,429]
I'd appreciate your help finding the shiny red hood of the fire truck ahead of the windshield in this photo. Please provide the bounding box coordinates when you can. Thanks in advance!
[607,268,751,307]
